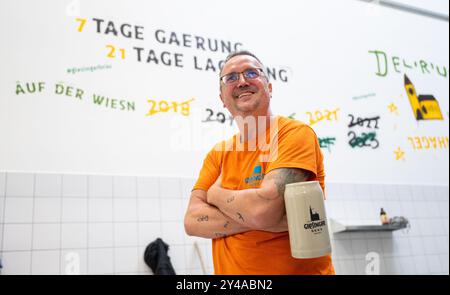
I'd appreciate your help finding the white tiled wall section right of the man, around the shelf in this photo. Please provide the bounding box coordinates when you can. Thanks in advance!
[327,184,449,274]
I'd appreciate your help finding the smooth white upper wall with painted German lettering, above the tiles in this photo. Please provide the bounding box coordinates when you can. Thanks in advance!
[0,0,449,185]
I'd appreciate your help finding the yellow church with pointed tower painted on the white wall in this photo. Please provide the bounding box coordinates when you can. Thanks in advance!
[405,75,444,120]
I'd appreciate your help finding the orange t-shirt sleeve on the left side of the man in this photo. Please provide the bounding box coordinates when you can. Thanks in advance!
[192,148,221,191]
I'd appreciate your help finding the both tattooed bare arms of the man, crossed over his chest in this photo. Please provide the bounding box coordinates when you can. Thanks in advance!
[184,168,310,239]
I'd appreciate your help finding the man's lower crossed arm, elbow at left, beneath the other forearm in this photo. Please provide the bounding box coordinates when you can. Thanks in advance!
[184,190,287,239]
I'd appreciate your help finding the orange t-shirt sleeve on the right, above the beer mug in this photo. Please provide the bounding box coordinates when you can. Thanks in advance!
[267,125,324,179]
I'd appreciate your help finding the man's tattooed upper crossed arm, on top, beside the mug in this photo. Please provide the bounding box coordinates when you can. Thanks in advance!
[207,168,310,230]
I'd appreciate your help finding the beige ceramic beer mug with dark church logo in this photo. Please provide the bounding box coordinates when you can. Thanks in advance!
[284,181,331,259]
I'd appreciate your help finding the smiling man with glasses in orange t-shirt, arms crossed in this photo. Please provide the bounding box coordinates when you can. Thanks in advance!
[185,51,334,274]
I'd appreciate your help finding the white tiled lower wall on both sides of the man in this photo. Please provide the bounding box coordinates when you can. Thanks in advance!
[0,173,449,275]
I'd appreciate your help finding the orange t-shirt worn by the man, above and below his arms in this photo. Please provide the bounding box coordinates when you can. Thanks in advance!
[193,117,334,274]
